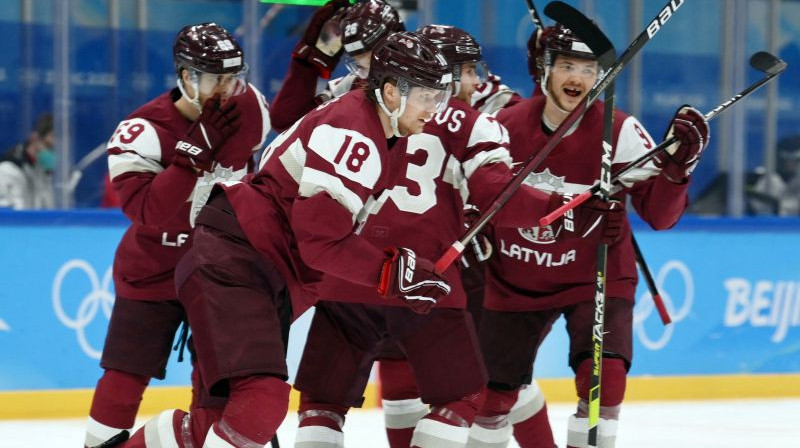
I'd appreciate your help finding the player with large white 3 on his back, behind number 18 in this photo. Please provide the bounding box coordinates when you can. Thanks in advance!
[294,25,620,448]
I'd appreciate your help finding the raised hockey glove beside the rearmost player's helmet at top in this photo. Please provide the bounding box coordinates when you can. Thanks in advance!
[292,0,349,79]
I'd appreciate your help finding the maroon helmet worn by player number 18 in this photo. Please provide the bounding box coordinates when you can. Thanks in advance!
[367,31,453,90]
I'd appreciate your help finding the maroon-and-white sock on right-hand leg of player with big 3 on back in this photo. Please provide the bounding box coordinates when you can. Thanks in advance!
[411,389,485,448]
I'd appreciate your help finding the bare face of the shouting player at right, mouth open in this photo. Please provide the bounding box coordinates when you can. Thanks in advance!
[547,55,599,112]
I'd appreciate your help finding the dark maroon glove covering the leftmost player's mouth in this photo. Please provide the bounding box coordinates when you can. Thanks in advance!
[174,95,240,172]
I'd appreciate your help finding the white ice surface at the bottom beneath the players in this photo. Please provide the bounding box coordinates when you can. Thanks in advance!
[0,398,800,448]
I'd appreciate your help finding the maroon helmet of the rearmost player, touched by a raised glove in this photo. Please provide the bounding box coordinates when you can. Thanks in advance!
[341,0,405,56]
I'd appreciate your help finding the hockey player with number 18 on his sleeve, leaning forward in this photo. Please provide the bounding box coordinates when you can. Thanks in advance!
[116,32,460,448]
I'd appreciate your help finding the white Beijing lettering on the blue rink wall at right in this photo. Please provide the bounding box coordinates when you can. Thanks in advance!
[724,277,800,344]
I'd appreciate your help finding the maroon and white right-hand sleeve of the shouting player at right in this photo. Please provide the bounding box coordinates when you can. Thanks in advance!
[612,116,689,230]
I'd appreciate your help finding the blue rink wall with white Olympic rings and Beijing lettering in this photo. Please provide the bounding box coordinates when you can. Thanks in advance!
[0,210,800,410]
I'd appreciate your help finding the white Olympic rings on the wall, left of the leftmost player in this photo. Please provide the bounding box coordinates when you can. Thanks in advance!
[52,259,114,359]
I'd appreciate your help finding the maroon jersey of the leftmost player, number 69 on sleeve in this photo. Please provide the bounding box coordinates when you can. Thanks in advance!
[108,85,270,300]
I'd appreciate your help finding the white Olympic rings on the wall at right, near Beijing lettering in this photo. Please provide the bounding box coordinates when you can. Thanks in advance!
[633,260,694,350]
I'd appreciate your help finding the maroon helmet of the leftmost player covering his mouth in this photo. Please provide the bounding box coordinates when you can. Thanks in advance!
[172,22,242,74]
